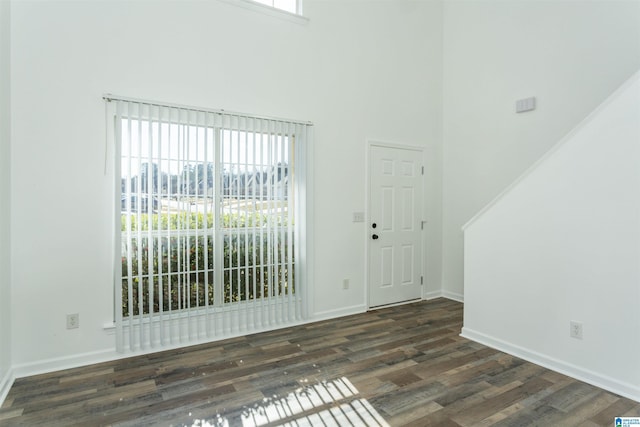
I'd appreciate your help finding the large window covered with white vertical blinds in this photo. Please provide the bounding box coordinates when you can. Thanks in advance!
[105,97,310,351]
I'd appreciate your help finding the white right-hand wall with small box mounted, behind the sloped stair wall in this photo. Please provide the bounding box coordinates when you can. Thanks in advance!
[443,0,640,298]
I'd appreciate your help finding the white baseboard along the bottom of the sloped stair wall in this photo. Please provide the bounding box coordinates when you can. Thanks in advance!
[460,327,640,402]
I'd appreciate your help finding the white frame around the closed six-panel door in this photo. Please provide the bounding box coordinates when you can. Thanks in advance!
[364,138,427,310]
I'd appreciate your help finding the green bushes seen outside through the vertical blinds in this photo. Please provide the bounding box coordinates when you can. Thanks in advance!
[121,212,295,317]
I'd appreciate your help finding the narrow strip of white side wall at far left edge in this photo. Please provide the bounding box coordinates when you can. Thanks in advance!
[0,1,11,402]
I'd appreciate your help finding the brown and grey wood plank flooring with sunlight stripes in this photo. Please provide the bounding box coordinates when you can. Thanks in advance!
[0,299,640,427]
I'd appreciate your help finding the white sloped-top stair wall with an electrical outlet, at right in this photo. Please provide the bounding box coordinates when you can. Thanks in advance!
[463,72,640,401]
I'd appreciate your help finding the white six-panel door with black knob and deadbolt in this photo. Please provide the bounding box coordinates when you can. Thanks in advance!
[368,145,423,307]
